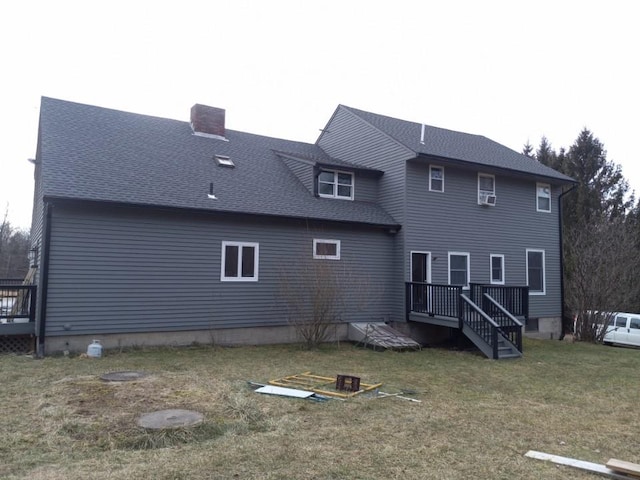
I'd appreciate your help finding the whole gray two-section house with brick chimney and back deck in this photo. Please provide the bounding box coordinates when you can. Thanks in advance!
[20,98,572,356]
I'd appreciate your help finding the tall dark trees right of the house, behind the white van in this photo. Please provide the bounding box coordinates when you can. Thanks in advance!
[523,128,640,341]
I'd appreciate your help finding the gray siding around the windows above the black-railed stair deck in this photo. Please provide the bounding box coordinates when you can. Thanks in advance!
[404,162,561,317]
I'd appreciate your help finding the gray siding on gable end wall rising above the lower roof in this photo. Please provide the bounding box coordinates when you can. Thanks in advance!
[318,108,415,223]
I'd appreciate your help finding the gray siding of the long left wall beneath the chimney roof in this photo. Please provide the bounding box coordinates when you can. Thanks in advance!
[47,206,402,336]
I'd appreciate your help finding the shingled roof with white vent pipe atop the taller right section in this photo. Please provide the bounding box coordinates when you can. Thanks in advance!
[339,105,575,183]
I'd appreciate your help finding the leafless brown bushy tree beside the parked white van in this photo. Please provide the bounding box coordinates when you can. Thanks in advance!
[565,216,640,342]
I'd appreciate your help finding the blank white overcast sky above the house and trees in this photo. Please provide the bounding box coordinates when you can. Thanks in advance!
[0,0,640,228]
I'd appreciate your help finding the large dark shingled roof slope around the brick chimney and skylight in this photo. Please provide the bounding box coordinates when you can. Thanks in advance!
[39,97,397,227]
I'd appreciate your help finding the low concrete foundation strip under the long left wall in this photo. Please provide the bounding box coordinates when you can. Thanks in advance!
[45,323,348,355]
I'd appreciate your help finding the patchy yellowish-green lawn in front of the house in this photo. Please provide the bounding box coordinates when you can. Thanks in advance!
[0,340,640,480]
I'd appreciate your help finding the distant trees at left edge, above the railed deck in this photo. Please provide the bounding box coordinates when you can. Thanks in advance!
[0,207,29,279]
